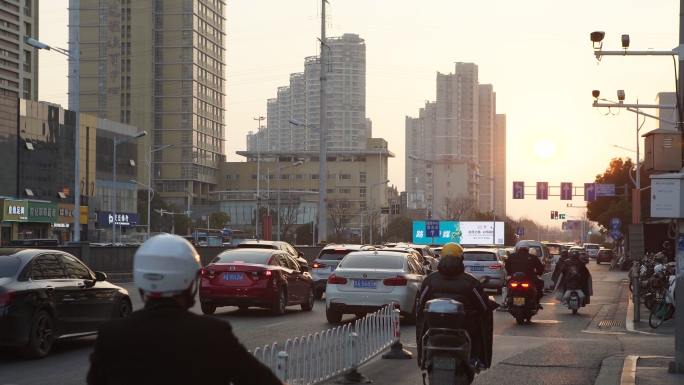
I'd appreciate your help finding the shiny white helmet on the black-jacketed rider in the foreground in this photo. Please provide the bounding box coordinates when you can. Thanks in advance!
[133,234,202,298]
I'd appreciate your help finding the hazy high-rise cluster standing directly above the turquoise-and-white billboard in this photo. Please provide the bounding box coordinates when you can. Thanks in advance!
[405,63,505,218]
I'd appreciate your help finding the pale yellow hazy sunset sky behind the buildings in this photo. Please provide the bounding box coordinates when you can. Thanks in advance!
[39,0,679,227]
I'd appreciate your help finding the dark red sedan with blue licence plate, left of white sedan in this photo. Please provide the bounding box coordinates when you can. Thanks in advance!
[199,249,315,316]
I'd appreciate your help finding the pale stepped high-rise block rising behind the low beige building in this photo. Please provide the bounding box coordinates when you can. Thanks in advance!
[247,33,371,152]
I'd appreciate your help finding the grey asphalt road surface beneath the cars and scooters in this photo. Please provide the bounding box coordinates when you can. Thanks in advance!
[0,261,673,385]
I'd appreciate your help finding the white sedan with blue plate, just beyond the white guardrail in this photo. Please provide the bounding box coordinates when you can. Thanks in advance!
[325,250,425,324]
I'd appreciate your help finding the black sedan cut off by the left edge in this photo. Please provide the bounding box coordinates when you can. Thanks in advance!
[0,249,132,358]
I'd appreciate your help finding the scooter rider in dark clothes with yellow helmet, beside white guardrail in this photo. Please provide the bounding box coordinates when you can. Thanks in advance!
[416,242,491,370]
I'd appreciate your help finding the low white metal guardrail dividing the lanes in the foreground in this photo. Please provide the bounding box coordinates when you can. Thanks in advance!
[253,304,400,385]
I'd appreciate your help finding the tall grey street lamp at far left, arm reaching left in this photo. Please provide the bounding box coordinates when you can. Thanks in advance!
[26,38,81,242]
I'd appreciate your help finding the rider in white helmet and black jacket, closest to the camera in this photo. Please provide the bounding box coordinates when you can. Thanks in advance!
[87,234,282,385]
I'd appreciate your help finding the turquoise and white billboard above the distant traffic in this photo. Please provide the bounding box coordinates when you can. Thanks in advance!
[413,221,504,246]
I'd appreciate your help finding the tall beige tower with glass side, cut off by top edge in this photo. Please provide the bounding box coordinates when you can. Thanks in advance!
[69,0,226,207]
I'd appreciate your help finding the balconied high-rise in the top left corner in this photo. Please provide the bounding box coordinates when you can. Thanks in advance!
[0,0,38,101]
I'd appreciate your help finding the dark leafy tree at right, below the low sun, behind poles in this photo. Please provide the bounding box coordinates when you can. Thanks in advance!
[587,158,651,234]
